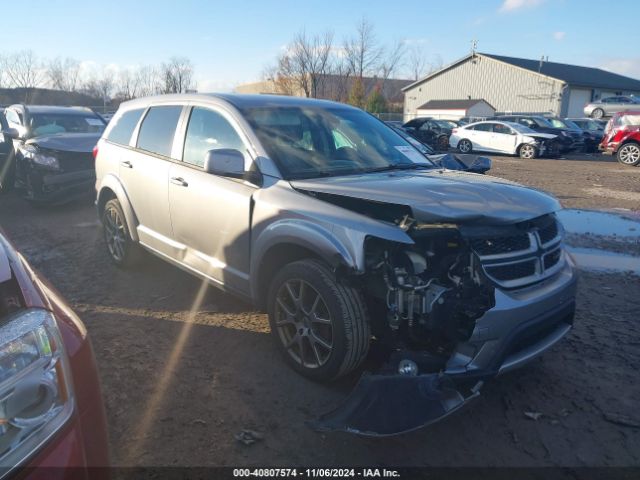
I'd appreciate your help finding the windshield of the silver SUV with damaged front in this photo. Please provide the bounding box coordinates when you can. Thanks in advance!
[244,107,435,179]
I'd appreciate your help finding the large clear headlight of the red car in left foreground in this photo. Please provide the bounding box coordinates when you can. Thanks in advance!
[0,309,73,468]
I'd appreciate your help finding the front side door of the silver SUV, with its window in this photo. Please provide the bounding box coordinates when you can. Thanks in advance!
[169,106,257,292]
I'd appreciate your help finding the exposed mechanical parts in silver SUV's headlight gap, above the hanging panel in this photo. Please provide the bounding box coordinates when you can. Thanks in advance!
[366,216,495,373]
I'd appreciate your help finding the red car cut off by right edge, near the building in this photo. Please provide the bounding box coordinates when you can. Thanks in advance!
[599,111,640,166]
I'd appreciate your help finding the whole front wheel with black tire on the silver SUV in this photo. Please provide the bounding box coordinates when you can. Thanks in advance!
[267,259,371,381]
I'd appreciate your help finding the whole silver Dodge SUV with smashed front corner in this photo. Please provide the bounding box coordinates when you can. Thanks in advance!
[96,95,576,434]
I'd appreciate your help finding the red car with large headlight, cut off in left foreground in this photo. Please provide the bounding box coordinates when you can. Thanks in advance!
[0,232,109,480]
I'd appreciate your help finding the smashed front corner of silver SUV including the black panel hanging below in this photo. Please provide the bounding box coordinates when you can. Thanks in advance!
[313,215,495,436]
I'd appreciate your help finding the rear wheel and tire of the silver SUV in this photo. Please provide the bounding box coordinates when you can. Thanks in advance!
[100,198,142,268]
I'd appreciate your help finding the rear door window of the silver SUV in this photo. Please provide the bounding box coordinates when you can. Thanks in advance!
[137,105,182,157]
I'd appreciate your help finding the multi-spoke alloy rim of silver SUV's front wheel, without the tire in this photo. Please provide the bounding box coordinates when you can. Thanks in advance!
[275,279,333,368]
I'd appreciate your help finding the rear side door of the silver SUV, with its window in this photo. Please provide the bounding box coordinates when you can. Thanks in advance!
[119,104,184,257]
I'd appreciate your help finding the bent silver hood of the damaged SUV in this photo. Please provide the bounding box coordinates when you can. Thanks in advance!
[291,170,561,225]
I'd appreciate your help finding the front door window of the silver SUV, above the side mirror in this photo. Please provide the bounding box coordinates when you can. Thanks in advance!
[182,107,245,167]
